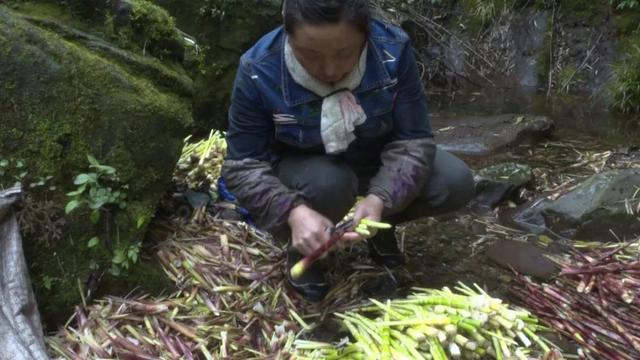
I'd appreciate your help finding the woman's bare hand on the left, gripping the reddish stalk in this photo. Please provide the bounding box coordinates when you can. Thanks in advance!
[287,205,333,255]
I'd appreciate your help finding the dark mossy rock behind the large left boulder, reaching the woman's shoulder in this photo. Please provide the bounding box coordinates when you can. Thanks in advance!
[15,0,282,136]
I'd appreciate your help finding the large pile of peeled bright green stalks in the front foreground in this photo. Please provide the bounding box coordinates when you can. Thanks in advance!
[294,284,560,360]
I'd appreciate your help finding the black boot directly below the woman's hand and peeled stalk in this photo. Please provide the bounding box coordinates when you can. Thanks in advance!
[287,246,329,302]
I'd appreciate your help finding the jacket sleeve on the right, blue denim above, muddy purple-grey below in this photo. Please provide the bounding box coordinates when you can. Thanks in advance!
[368,42,436,215]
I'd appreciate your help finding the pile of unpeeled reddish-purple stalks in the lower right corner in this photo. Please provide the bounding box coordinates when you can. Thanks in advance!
[514,239,640,360]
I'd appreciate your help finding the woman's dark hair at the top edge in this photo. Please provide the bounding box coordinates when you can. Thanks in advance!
[282,0,371,35]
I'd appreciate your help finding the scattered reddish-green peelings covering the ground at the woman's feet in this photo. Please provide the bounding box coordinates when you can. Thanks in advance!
[47,217,382,360]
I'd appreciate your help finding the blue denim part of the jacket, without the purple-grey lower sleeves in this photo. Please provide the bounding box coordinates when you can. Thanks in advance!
[227,20,432,163]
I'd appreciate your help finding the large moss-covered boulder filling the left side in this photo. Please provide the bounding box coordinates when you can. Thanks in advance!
[0,6,193,321]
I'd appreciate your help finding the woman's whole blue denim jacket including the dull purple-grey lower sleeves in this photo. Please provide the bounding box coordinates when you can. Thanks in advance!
[222,20,435,231]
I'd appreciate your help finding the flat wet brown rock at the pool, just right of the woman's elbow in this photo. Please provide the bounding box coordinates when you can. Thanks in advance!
[432,114,554,157]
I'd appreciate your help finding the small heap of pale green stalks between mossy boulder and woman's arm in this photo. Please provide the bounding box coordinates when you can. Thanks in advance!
[173,130,227,194]
